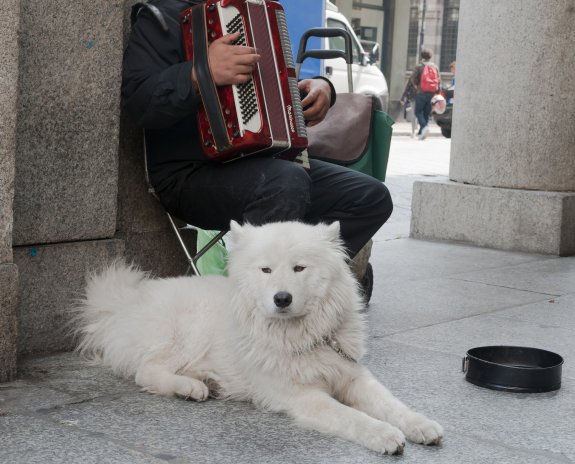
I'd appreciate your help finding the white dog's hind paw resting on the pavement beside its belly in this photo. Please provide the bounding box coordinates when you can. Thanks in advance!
[135,362,208,401]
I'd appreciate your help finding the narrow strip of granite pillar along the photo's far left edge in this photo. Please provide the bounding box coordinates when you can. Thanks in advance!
[0,0,20,382]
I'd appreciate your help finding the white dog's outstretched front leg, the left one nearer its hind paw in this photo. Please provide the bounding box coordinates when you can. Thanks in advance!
[284,389,405,454]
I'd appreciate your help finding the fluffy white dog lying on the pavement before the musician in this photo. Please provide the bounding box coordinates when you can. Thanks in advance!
[76,222,443,454]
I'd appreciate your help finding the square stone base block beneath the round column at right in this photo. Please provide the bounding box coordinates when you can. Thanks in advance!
[410,181,575,256]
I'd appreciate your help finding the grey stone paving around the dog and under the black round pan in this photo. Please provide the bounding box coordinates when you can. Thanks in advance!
[0,136,575,464]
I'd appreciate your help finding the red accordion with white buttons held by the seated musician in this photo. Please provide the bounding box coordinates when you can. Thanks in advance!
[180,0,307,162]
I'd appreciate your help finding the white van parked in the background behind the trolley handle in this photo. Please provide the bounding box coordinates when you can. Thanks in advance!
[324,0,389,111]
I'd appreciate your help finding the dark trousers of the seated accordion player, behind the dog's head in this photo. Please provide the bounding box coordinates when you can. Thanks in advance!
[158,158,393,257]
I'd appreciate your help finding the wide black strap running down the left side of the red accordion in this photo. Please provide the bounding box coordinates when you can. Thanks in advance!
[192,4,231,151]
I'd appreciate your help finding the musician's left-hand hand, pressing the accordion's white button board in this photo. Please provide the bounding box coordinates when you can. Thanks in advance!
[208,32,260,85]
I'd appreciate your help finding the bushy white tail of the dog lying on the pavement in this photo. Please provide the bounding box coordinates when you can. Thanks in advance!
[71,260,149,359]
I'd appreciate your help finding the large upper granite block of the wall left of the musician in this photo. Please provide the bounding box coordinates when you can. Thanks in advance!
[13,0,123,246]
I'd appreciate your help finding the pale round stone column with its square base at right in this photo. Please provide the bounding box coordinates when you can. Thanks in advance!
[411,0,575,256]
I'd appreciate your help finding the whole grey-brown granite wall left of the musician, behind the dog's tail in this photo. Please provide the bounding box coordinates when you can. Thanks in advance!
[0,0,187,370]
